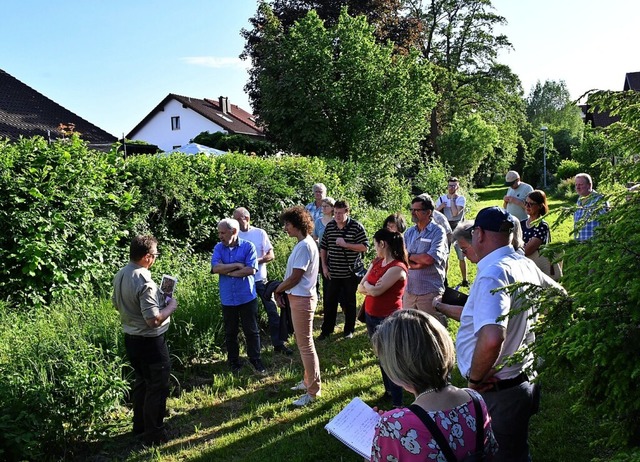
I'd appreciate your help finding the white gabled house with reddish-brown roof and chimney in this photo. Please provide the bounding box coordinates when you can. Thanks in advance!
[127,93,265,151]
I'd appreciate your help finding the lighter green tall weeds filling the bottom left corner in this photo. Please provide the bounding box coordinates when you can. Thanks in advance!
[0,299,127,460]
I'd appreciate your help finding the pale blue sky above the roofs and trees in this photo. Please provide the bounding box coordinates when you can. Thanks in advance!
[0,0,640,136]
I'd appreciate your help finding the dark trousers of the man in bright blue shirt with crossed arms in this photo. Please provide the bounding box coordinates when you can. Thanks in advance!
[222,297,260,365]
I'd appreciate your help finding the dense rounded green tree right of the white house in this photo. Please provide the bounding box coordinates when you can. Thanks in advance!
[250,5,435,162]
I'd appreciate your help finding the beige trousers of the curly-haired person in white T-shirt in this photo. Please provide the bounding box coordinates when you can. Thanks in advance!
[288,295,320,397]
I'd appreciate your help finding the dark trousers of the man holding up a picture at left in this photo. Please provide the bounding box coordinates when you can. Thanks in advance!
[124,334,171,437]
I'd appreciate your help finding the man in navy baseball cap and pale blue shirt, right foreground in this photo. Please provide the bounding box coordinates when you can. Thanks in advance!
[456,207,560,462]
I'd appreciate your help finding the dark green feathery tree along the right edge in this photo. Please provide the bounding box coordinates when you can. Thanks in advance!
[536,87,640,452]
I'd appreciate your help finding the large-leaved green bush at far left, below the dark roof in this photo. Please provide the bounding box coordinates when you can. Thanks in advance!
[0,136,135,306]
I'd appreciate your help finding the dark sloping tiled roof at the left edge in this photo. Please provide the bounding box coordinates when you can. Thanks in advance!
[0,69,117,150]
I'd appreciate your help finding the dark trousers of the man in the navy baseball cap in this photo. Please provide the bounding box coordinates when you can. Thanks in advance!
[482,382,534,462]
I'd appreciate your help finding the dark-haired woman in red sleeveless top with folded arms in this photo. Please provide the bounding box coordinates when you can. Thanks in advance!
[358,228,409,407]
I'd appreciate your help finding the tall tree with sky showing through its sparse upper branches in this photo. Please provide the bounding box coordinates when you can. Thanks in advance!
[407,0,522,155]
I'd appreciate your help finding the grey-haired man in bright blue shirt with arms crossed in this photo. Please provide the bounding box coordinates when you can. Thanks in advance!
[211,218,266,374]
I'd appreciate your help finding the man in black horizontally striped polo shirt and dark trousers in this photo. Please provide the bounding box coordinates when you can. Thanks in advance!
[318,201,369,340]
